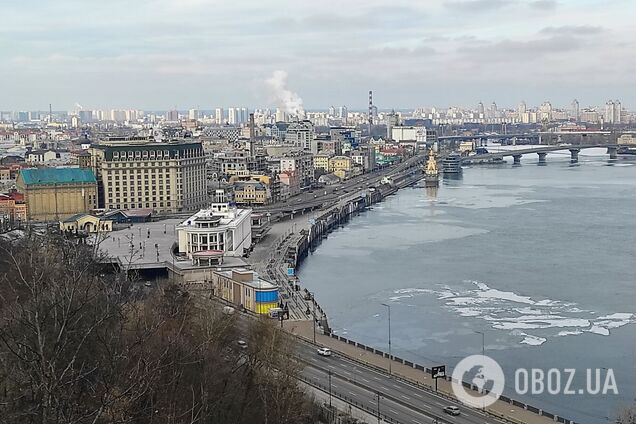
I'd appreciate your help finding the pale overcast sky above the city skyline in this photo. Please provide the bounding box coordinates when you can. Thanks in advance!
[0,0,636,110]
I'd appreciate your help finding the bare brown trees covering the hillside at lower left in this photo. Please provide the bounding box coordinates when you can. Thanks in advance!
[0,235,320,424]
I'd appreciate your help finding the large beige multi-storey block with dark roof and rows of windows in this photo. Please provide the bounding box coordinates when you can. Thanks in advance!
[89,137,208,212]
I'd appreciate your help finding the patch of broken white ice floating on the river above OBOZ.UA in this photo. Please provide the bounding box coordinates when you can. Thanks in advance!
[390,281,636,346]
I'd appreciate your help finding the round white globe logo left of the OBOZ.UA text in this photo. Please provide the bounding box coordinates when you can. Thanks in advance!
[451,355,505,408]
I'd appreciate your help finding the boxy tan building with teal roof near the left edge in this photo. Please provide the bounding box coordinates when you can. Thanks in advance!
[16,168,97,221]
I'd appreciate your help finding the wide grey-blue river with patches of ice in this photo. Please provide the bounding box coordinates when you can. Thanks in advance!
[299,149,636,423]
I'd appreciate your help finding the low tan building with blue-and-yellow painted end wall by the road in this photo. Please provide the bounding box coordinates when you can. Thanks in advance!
[212,269,279,314]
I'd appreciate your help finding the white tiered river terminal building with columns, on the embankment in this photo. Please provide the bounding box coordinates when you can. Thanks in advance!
[177,203,252,258]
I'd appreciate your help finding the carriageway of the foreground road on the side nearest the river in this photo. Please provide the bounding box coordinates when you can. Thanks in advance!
[301,345,502,423]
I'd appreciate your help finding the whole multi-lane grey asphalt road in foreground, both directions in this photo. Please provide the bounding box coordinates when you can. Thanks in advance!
[298,342,504,424]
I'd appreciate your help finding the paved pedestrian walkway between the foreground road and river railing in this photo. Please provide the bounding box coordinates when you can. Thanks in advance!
[285,321,554,424]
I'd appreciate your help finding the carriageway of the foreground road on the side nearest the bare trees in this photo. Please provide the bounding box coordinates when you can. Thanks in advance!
[303,367,448,424]
